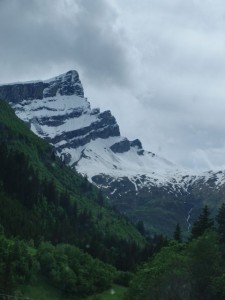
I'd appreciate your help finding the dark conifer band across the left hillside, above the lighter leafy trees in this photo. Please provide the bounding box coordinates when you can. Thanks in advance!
[0,142,166,271]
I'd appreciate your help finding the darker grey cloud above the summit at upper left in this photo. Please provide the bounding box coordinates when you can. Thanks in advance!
[0,0,128,84]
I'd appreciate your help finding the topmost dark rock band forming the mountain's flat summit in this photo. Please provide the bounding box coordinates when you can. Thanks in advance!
[0,71,84,103]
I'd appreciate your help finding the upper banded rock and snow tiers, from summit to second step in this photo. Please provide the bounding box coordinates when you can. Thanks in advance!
[0,71,120,155]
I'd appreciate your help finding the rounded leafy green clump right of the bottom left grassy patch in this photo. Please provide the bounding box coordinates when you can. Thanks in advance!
[37,243,116,295]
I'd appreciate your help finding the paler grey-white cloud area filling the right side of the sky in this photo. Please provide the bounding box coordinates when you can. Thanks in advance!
[104,0,225,169]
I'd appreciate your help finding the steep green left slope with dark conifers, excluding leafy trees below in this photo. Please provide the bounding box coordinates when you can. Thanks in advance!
[0,101,146,269]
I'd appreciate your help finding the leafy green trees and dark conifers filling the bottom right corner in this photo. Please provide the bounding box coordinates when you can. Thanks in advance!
[126,204,225,300]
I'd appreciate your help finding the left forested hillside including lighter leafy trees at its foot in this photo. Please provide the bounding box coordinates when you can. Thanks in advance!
[0,101,158,296]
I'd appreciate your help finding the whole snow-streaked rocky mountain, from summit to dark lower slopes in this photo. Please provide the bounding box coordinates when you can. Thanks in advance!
[0,71,225,235]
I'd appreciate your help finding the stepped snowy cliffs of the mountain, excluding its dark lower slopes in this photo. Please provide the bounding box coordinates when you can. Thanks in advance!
[0,71,171,179]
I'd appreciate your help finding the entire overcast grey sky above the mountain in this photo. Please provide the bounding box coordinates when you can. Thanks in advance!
[0,0,225,170]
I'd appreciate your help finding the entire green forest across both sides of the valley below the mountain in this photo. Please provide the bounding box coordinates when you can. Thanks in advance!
[0,97,225,300]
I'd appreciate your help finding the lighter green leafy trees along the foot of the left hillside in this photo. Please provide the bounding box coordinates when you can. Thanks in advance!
[0,227,116,296]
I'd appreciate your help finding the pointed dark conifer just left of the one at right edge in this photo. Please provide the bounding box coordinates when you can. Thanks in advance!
[191,205,214,238]
